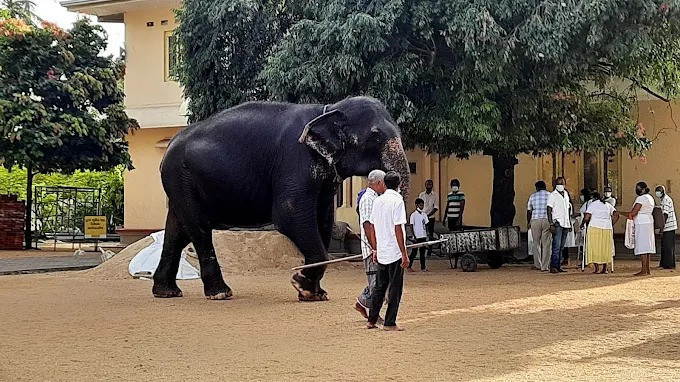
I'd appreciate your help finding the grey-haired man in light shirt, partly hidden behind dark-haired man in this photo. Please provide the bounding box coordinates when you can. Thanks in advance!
[354,170,385,319]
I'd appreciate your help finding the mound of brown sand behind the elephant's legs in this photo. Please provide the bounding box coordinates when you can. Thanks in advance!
[80,231,303,280]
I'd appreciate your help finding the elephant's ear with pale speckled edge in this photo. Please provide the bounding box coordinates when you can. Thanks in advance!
[298,110,347,164]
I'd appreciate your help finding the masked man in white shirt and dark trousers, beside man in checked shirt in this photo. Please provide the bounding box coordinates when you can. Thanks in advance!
[547,176,571,273]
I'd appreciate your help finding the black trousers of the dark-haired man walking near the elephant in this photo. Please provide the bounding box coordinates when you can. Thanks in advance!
[368,259,404,326]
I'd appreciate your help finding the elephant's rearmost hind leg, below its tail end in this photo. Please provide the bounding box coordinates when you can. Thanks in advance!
[152,208,189,297]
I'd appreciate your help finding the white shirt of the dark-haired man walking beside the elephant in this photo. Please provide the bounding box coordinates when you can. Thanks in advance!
[371,189,406,265]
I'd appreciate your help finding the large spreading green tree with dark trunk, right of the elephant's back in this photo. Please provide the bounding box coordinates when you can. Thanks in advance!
[177,0,680,225]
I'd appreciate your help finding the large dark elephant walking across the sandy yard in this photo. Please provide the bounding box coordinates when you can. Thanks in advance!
[152,96,409,301]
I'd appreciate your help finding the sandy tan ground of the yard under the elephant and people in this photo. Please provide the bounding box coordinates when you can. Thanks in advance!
[0,258,680,381]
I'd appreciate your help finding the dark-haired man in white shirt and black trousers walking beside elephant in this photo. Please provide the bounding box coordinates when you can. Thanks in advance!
[366,171,408,330]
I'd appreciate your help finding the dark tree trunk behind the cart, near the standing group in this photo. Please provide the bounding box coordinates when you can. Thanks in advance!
[491,154,518,227]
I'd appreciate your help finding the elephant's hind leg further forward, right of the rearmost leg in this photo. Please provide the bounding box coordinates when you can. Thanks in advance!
[188,224,233,300]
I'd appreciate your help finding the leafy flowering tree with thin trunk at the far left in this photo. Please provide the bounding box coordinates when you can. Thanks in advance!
[0,19,137,248]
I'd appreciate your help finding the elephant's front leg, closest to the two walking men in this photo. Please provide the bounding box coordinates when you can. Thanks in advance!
[273,199,328,301]
